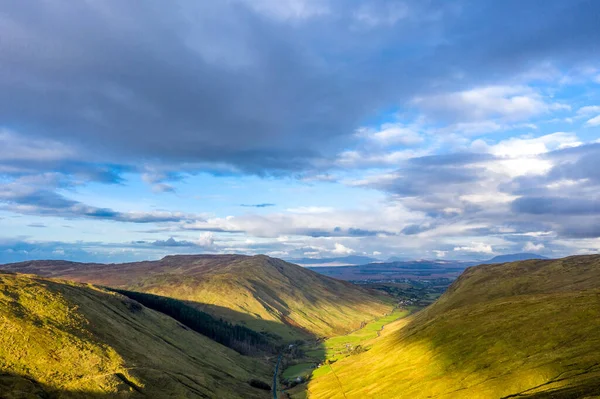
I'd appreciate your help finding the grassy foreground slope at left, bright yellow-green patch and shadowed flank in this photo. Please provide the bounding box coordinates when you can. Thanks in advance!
[0,273,271,398]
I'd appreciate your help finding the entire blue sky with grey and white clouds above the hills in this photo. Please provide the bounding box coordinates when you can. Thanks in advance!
[0,0,600,263]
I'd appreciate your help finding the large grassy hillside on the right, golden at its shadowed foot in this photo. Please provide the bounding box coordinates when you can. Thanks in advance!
[309,256,600,398]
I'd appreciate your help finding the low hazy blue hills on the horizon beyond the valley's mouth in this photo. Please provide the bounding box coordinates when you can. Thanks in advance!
[308,260,475,281]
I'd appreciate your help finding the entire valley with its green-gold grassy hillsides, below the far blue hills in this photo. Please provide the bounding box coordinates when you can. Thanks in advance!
[0,255,600,399]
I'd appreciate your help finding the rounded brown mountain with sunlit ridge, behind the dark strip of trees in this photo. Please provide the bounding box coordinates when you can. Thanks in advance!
[0,255,393,341]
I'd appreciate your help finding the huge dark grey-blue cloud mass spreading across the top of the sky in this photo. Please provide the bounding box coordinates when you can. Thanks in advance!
[0,0,600,174]
